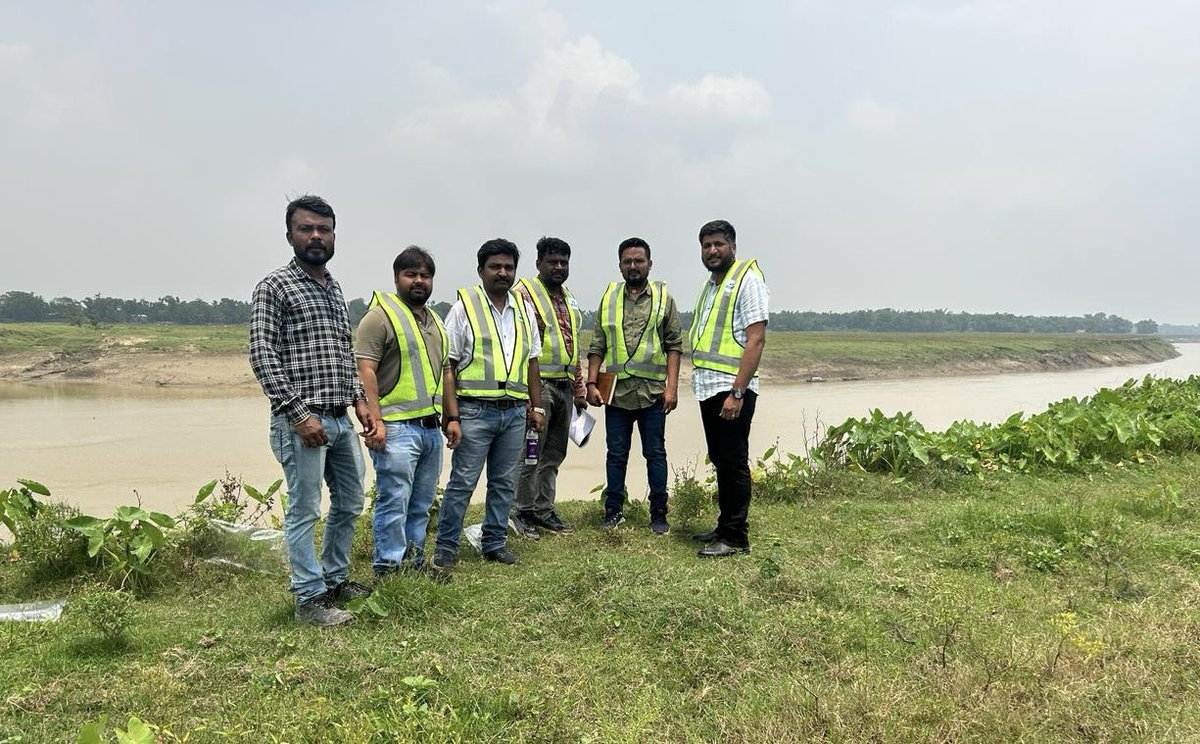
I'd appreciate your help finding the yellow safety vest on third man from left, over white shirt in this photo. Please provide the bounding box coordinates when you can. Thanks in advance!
[457,286,533,400]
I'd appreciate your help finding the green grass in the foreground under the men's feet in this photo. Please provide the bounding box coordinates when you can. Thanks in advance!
[0,457,1200,742]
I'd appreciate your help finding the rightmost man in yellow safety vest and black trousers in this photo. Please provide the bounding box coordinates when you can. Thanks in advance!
[689,220,770,558]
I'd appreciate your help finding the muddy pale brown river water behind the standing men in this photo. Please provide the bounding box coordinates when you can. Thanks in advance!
[0,344,1200,514]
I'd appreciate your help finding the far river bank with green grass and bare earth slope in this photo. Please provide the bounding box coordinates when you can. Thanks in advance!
[0,324,1178,392]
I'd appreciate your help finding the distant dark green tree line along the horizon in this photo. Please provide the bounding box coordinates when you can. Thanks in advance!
[0,292,1158,334]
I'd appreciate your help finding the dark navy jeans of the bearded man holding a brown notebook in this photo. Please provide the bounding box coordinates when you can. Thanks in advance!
[604,398,667,516]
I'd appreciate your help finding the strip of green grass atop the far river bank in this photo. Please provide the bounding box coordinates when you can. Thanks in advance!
[0,323,1176,380]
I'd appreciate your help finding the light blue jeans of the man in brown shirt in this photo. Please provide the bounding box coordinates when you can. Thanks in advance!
[370,421,442,574]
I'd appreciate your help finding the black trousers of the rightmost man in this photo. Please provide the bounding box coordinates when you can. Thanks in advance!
[700,390,758,547]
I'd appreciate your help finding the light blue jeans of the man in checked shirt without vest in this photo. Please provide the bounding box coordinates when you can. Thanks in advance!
[271,414,365,602]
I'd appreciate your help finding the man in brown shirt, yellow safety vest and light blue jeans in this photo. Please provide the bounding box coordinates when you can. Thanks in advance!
[354,246,450,580]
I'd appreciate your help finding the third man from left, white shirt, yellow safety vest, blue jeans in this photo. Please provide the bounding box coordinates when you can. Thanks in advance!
[433,238,545,569]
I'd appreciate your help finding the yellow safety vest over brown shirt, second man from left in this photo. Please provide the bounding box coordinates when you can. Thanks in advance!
[371,292,450,421]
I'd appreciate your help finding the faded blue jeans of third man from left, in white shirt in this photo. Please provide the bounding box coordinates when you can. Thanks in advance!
[437,398,526,554]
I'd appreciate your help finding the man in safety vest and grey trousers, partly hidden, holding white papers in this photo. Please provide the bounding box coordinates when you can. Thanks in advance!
[509,238,587,540]
